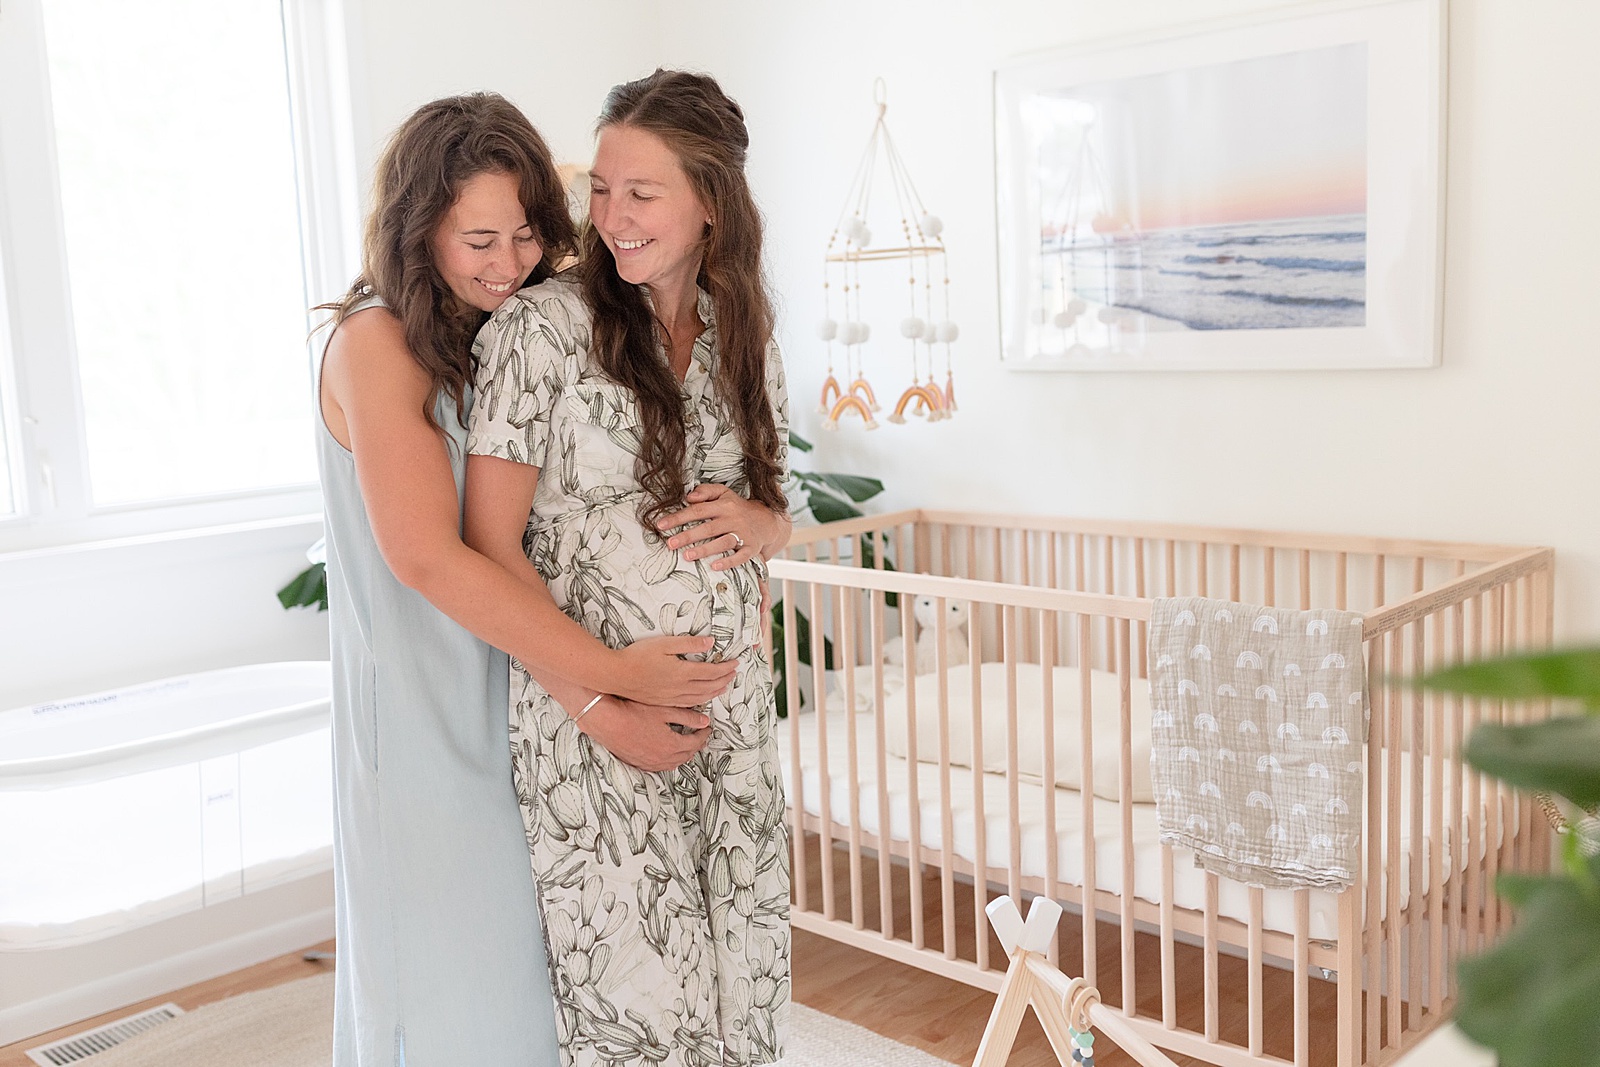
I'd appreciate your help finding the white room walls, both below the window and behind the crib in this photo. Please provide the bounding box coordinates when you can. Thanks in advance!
[15,0,1600,707]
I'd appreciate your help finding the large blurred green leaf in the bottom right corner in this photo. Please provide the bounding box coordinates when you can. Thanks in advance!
[1456,857,1600,1067]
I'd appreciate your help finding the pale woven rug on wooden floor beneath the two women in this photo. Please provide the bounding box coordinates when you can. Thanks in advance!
[72,973,949,1067]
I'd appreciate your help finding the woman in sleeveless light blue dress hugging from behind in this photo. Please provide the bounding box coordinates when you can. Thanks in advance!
[318,93,733,1067]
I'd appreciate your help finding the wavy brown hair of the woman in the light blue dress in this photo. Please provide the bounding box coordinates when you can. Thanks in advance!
[323,93,578,430]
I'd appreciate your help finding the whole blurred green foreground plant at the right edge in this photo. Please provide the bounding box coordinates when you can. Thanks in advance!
[1419,648,1600,1067]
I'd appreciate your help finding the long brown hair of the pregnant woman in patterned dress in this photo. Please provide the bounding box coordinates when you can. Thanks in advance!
[578,70,787,530]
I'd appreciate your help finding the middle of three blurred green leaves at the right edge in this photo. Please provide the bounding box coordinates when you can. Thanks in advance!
[1466,715,1600,809]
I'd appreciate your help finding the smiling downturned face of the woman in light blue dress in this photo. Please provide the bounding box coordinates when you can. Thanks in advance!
[430,171,544,312]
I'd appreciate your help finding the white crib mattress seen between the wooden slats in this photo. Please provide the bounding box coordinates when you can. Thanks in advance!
[778,709,1518,941]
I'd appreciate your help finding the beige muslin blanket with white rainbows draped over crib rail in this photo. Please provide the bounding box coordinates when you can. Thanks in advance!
[1149,597,1366,891]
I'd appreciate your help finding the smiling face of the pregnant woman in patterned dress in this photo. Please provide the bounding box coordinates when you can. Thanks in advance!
[589,125,710,306]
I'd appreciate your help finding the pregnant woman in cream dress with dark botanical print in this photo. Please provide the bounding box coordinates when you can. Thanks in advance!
[466,70,789,1067]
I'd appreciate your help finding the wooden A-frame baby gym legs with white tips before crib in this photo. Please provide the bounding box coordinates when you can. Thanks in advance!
[973,896,1176,1067]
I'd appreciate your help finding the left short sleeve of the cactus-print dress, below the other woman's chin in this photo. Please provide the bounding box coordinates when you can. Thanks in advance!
[467,294,570,467]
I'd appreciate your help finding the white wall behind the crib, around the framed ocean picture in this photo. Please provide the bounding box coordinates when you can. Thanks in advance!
[658,0,1600,638]
